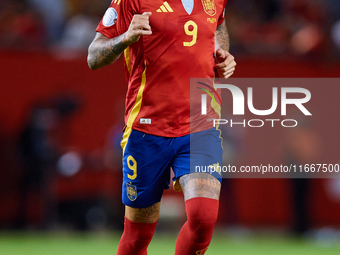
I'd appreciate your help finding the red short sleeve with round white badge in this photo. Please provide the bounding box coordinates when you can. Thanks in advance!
[96,0,121,38]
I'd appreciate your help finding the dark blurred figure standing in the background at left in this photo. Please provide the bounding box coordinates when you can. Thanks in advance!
[15,95,79,229]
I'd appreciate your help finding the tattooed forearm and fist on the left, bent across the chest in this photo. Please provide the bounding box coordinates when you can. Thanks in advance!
[87,12,152,70]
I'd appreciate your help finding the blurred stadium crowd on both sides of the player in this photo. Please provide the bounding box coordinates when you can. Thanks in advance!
[0,0,340,60]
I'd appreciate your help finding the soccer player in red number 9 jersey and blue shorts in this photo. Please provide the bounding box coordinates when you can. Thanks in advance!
[88,0,236,255]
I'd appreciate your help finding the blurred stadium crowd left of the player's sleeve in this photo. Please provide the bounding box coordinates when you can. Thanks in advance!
[0,0,110,50]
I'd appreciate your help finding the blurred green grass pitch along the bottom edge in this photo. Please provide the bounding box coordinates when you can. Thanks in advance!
[0,232,340,255]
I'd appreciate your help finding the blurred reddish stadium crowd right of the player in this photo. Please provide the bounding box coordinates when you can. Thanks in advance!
[226,0,340,59]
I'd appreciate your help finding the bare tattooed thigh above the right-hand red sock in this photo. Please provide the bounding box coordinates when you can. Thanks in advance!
[179,173,221,201]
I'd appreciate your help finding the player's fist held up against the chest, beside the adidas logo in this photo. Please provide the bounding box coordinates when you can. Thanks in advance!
[122,12,152,45]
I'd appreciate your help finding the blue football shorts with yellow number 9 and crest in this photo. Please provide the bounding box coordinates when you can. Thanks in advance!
[121,127,223,208]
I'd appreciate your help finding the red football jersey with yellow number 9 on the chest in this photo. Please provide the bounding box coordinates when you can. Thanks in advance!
[97,0,226,137]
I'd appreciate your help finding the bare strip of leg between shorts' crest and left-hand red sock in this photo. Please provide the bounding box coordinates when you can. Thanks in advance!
[125,202,161,223]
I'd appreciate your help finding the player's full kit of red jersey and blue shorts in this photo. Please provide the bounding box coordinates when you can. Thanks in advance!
[97,0,226,208]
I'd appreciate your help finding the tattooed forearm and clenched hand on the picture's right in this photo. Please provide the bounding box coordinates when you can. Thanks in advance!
[215,21,236,78]
